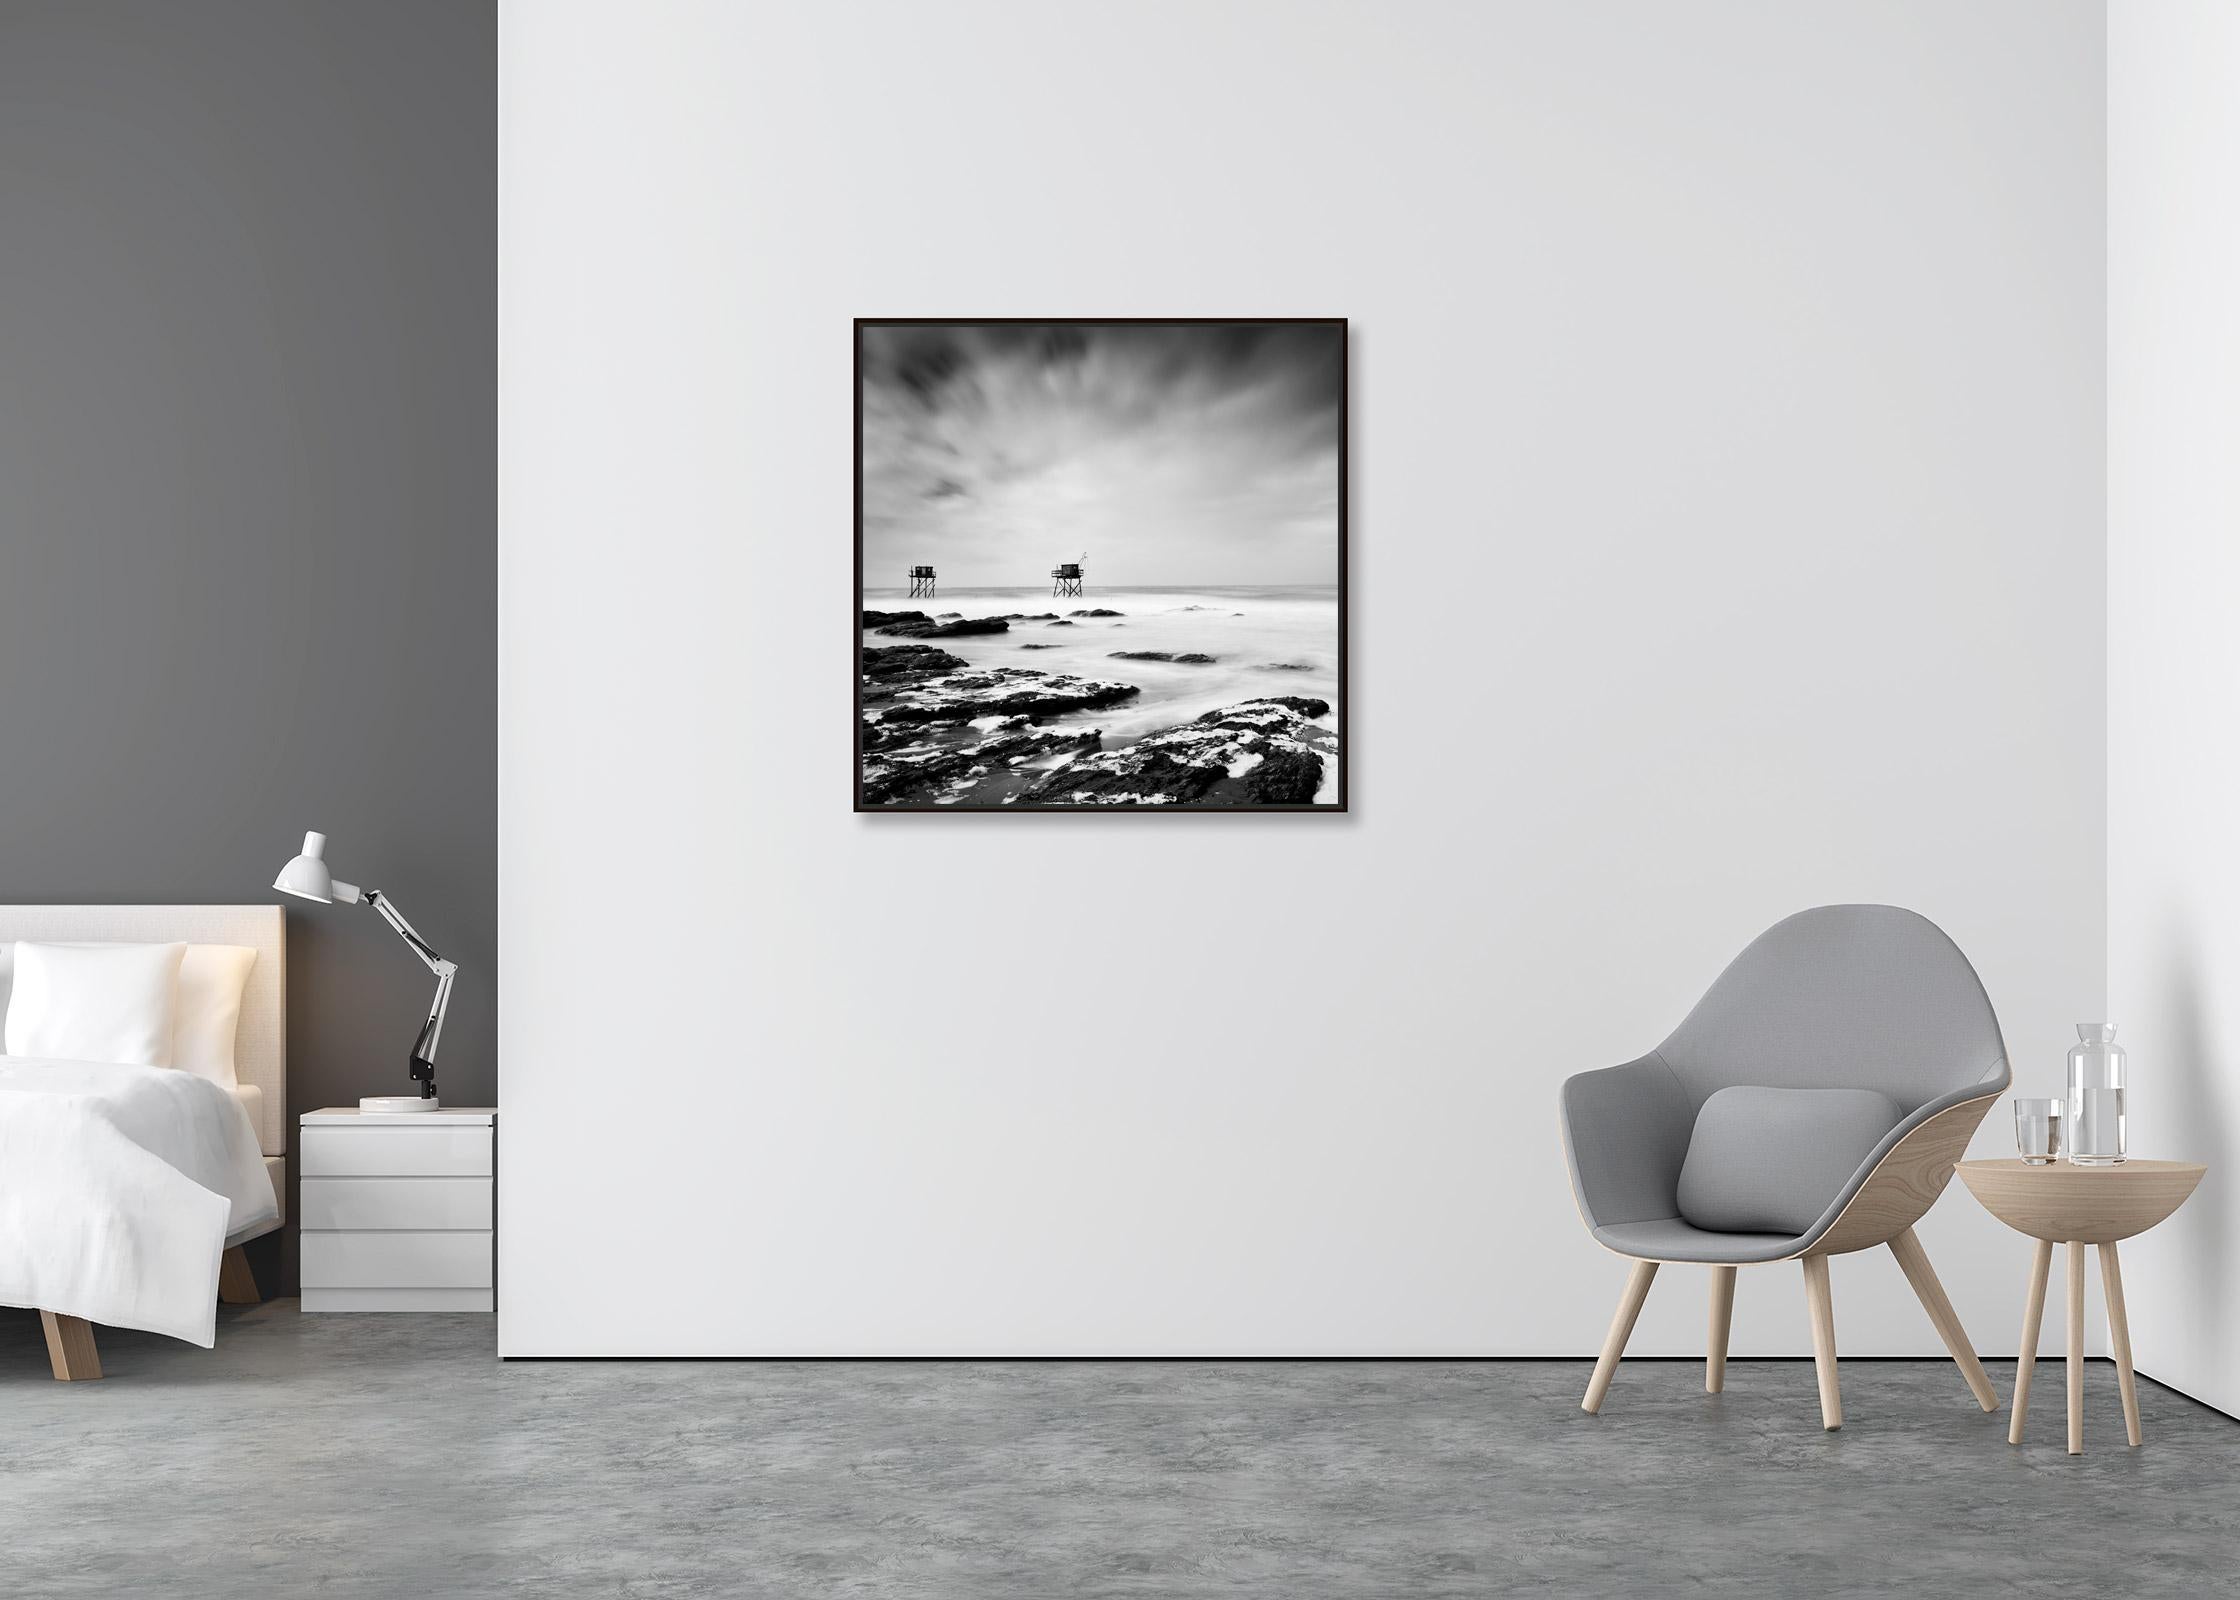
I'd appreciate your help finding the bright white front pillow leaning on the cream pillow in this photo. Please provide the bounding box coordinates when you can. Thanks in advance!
[7,939,186,1067]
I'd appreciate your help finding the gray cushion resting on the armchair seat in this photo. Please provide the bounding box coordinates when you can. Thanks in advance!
[1680,1085,1904,1235]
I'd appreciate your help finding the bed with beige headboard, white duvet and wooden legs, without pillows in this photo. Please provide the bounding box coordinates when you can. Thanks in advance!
[0,905,287,1378]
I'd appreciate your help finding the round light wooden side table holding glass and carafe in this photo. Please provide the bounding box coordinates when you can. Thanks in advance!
[1956,1159,2209,1457]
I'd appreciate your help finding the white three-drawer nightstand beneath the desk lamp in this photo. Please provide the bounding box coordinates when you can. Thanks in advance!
[300,1107,497,1311]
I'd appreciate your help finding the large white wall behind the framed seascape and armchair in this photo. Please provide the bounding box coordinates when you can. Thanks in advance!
[500,0,2106,1354]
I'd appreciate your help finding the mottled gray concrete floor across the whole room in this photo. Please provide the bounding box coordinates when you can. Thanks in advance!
[0,1300,2240,1600]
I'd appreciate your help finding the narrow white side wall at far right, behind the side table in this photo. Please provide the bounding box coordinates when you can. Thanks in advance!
[2108,0,2240,1412]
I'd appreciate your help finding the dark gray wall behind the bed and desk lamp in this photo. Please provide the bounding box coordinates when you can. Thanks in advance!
[0,0,497,1286]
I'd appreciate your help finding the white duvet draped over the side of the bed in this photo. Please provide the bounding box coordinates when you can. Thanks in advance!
[0,1055,280,1349]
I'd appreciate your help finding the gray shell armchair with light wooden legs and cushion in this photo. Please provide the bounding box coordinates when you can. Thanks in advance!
[1564,905,2009,1427]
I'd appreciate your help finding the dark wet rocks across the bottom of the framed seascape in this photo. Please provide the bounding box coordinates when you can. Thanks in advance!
[860,607,1337,807]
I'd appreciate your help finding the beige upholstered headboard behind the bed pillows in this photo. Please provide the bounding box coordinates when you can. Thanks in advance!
[0,905,287,1156]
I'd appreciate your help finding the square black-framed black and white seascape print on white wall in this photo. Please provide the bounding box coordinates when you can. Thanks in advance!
[856,318,1348,811]
